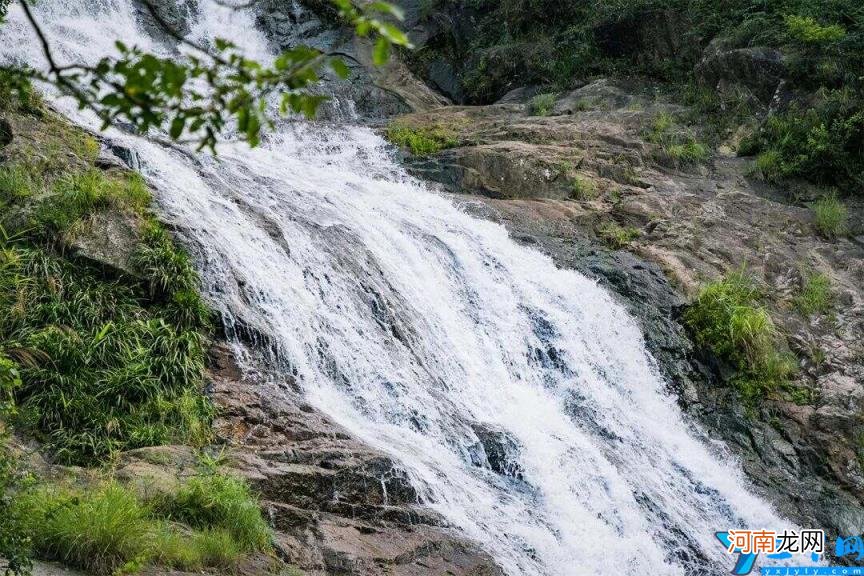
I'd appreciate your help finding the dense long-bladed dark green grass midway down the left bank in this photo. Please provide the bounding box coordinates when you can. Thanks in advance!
[0,247,212,464]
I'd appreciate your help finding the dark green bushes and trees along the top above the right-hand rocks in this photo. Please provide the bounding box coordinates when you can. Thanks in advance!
[409,0,864,194]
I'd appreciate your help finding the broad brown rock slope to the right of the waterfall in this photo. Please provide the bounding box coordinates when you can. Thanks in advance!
[386,82,864,534]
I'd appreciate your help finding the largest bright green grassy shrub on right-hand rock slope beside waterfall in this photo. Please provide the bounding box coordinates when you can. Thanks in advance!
[684,272,795,402]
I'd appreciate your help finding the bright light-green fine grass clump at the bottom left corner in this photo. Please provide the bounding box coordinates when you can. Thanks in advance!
[12,475,270,575]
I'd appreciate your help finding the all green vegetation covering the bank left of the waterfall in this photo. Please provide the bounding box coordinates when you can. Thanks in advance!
[0,75,270,574]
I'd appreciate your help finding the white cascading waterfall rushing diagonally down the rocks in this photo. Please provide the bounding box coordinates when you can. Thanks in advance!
[2,0,804,576]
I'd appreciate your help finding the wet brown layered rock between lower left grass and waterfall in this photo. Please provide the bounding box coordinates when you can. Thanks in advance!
[203,345,501,576]
